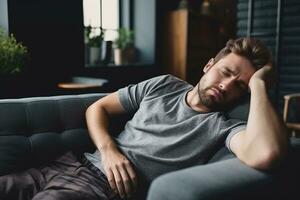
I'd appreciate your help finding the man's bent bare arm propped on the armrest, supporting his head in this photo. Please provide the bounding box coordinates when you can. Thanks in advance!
[230,65,288,170]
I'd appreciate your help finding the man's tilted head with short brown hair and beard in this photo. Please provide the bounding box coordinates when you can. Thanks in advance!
[197,38,271,110]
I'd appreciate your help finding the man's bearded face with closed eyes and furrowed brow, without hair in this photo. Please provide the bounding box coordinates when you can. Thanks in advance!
[197,53,255,110]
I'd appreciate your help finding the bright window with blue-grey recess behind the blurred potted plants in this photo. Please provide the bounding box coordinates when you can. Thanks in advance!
[82,0,157,67]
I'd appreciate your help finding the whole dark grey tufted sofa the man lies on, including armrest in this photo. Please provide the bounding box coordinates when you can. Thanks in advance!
[0,93,300,200]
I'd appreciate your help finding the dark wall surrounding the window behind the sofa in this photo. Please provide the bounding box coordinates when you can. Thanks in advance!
[0,0,159,98]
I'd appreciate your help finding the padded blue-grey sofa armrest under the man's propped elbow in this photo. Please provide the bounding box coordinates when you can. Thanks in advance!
[147,138,300,200]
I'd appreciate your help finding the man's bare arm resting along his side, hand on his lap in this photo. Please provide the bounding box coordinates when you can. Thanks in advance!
[86,92,137,198]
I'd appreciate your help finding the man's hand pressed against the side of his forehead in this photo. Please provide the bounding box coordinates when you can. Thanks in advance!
[249,63,275,89]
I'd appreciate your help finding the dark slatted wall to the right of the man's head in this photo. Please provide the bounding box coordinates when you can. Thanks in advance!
[237,0,300,110]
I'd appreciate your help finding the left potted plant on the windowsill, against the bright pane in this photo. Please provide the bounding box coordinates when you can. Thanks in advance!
[85,26,104,65]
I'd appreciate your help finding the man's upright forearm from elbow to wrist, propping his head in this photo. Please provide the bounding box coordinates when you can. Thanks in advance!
[245,80,288,168]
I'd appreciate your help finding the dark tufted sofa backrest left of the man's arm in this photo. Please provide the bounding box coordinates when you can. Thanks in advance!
[0,94,106,175]
